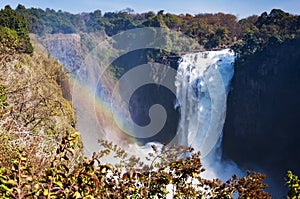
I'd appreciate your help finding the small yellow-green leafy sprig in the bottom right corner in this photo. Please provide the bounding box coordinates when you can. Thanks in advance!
[285,171,300,199]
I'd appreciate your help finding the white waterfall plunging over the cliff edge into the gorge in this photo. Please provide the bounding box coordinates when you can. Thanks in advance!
[175,49,241,180]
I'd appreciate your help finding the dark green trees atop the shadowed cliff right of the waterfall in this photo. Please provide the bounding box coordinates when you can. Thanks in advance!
[233,9,300,61]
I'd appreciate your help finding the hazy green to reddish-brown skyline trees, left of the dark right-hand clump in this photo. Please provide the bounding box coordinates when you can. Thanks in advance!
[11,5,239,48]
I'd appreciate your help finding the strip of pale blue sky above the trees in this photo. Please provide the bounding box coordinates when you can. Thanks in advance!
[0,0,300,18]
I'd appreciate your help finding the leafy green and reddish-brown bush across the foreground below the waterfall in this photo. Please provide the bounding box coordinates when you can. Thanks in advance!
[0,132,270,198]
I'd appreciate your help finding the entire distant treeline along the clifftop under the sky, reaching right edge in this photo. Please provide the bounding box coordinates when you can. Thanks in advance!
[0,5,300,55]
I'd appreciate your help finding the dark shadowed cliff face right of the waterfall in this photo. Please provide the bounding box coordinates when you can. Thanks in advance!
[222,39,300,196]
